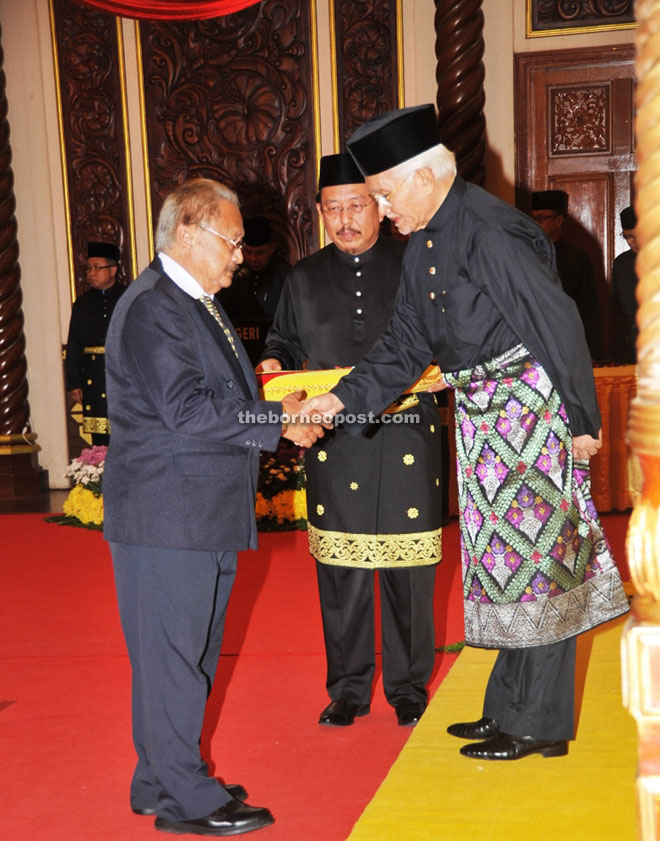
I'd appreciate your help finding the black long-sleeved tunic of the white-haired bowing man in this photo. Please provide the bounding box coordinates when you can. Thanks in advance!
[333,177,600,437]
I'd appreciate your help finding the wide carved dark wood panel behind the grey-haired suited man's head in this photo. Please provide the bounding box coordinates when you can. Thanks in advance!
[140,0,317,260]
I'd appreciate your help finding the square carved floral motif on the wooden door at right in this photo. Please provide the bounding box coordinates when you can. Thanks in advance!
[550,86,610,155]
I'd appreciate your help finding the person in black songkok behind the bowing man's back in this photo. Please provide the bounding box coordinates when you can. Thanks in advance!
[531,190,602,359]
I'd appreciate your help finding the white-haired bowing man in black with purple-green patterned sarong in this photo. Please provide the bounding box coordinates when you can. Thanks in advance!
[308,105,628,760]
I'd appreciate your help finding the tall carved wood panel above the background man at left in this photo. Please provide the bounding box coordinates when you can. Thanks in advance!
[53,0,130,293]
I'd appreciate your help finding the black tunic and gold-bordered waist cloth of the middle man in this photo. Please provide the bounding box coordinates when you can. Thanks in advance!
[262,237,442,568]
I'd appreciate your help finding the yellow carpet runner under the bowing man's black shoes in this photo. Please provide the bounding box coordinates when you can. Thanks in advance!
[349,619,637,841]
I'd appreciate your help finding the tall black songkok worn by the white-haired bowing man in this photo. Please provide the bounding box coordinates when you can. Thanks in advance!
[347,105,442,175]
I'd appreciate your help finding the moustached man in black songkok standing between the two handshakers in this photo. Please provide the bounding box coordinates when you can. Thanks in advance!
[261,154,442,726]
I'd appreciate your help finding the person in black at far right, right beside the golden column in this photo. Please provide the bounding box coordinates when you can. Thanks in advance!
[612,207,639,365]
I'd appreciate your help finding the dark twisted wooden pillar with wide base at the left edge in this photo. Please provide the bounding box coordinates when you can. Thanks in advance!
[0,28,48,511]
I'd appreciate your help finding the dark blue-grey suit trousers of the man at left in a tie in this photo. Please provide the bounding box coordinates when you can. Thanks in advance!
[110,542,236,820]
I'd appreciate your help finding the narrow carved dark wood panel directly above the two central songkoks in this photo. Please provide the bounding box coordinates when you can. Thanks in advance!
[335,0,399,143]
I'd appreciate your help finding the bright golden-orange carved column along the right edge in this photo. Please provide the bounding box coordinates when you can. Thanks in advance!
[622,0,660,841]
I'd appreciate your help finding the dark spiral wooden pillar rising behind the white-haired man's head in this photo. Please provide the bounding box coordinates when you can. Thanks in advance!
[435,0,486,184]
